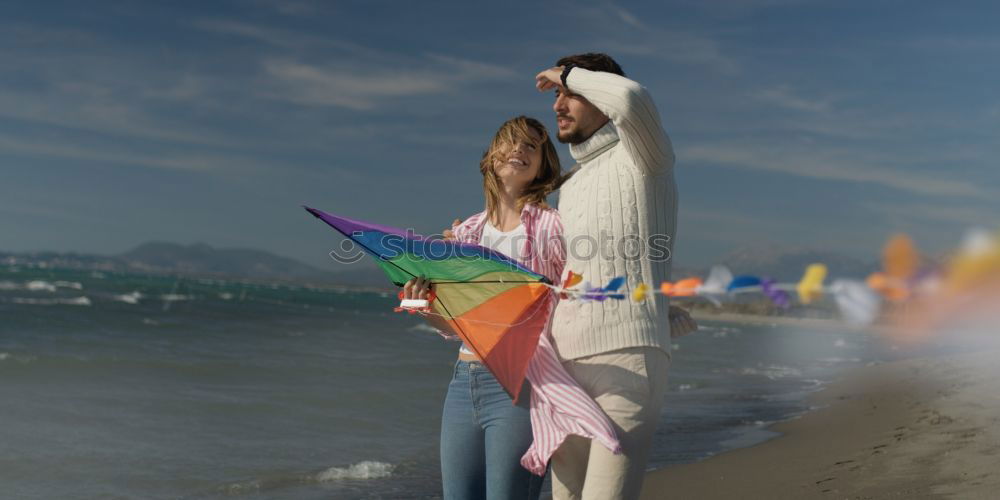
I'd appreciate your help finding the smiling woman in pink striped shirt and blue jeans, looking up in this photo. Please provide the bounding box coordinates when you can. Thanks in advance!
[404,116,618,500]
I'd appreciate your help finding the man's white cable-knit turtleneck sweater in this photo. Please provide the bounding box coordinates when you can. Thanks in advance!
[552,68,677,360]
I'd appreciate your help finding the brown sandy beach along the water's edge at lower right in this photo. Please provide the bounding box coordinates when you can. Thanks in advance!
[642,350,1000,500]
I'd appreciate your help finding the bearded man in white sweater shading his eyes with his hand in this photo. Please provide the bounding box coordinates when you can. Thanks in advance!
[536,54,697,499]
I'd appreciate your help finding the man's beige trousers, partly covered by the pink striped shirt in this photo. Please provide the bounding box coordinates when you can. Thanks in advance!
[552,347,670,500]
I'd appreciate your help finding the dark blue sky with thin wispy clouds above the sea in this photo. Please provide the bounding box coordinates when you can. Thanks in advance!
[0,0,1000,269]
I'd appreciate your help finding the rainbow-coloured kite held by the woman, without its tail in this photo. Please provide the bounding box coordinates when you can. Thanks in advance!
[304,207,554,402]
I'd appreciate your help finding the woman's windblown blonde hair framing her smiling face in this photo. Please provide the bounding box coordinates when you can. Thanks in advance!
[479,115,562,223]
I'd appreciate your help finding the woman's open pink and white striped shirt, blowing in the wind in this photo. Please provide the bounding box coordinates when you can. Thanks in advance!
[453,204,621,476]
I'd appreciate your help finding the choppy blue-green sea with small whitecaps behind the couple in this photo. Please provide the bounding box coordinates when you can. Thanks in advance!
[0,267,916,499]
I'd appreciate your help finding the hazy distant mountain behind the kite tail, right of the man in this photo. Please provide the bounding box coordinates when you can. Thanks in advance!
[720,245,878,281]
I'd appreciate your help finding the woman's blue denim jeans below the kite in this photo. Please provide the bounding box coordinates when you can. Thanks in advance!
[441,360,543,500]
